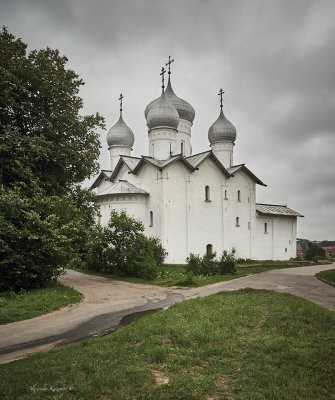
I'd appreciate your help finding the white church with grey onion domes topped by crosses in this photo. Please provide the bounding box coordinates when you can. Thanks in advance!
[92,59,302,264]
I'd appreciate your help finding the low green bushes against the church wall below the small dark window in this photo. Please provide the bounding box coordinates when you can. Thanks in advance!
[186,248,236,276]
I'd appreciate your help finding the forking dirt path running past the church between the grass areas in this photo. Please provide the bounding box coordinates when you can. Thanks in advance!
[0,263,335,364]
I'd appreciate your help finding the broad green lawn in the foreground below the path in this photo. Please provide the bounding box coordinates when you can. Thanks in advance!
[0,290,335,400]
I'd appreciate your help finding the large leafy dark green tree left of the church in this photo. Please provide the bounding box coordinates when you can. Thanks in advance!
[0,28,104,290]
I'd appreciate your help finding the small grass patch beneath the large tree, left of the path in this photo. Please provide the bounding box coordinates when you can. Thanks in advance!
[0,284,82,324]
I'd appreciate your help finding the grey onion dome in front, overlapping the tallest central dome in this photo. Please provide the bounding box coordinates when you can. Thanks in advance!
[146,92,179,129]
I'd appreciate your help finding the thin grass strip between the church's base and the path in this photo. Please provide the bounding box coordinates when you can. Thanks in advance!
[77,262,299,287]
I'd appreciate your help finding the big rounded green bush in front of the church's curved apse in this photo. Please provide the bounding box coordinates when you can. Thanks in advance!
[85,210,157,279]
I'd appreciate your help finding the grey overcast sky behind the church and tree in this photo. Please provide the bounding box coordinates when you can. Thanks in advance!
[0,0,335,240]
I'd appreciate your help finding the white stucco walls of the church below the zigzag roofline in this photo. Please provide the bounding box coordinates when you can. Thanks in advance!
[98,158,296,264]
